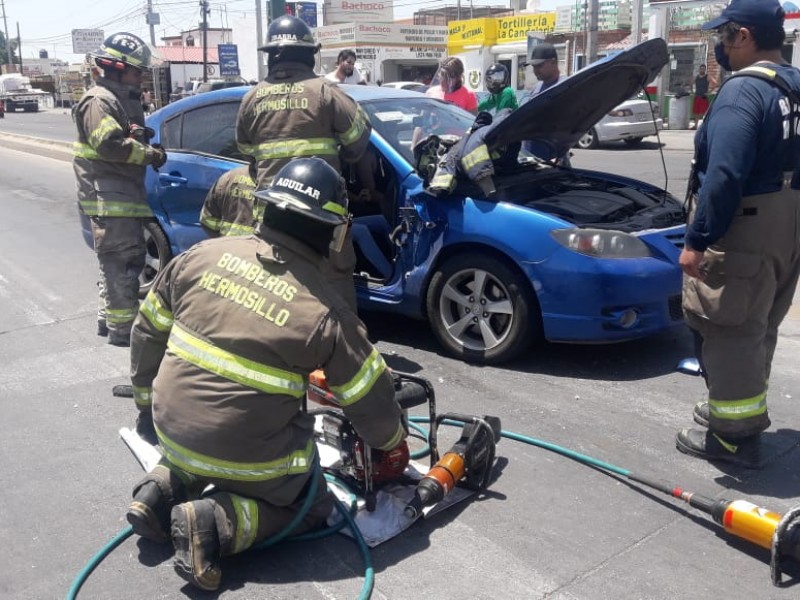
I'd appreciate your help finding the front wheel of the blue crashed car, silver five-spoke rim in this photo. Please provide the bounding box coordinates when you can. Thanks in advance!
[426,254,541,364]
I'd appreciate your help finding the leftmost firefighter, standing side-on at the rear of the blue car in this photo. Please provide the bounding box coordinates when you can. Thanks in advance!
[73,33,166,346]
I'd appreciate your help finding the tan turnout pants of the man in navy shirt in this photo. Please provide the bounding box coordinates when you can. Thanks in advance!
[683,185,800,439]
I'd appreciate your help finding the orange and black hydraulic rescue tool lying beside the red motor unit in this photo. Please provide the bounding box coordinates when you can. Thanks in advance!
[405,413,501,519]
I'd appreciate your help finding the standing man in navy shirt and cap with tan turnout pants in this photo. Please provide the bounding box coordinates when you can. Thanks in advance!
[676,0,800,468]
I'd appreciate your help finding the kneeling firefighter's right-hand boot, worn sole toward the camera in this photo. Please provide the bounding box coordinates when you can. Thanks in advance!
[172,498,222,592]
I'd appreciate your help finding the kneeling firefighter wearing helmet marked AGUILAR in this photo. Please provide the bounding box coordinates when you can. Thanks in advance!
[127,158,407,590]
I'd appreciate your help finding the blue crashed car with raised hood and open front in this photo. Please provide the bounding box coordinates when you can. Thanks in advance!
[79,40,685,364]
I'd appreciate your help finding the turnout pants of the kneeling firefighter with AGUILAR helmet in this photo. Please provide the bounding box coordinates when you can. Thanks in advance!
[138,460,334,556]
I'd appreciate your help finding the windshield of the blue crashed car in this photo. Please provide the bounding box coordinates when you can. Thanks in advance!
[362,95,475,165]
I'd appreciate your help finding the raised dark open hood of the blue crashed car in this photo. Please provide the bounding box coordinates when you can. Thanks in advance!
[485,38,669,156]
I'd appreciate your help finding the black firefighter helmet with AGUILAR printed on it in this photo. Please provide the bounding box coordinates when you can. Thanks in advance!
[255,158,348,227]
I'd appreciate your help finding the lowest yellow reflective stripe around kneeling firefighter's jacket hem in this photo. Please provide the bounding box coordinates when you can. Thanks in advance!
[156,425,315,481]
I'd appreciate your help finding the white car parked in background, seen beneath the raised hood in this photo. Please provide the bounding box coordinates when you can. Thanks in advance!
[576,98,664,149]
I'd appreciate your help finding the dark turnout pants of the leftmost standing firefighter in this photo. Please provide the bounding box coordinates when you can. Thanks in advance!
[91,217,146,335]
